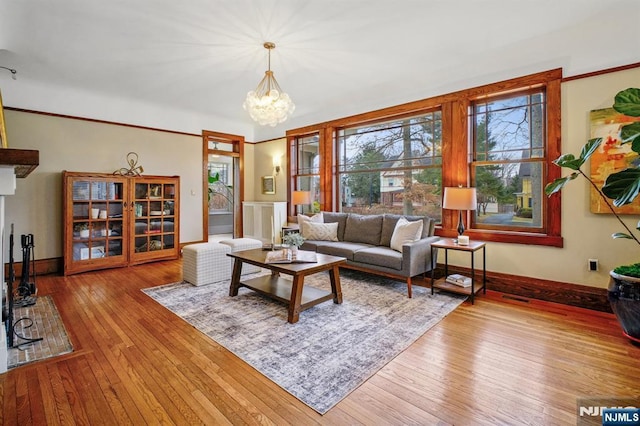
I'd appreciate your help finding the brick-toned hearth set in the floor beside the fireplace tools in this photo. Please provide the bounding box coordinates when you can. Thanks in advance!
[7,296,73,368]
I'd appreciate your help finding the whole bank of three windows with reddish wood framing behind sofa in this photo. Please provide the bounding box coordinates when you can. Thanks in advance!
[287,69,562,247]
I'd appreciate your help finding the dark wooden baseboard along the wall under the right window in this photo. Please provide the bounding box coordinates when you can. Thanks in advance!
[436,265,612,313]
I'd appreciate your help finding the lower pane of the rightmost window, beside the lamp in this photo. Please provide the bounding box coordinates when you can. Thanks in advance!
[474,161,544,232]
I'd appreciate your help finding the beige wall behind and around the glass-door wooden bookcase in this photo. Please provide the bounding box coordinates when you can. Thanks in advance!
[5,110,202,261]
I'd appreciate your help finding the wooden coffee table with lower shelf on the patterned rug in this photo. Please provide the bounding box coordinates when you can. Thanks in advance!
[227,249,347,323]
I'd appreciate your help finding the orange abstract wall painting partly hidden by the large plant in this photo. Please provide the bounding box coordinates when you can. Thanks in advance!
[589,108,640,215]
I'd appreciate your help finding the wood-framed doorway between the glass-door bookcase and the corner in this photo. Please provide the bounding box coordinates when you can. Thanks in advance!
[202,130,244,241]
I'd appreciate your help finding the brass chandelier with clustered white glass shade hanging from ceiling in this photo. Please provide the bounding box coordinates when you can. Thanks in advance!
[242,42,296,127]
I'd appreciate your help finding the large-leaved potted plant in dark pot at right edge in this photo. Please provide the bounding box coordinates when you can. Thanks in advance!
[545,88,640,344]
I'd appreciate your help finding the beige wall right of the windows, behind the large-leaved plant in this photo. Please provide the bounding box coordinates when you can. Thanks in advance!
[450,68,640,287]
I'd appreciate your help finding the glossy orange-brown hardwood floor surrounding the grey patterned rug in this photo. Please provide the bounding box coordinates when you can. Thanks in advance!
[0,261,640,425]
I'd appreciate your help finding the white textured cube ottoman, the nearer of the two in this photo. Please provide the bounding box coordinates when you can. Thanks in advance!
[182,242,231,285]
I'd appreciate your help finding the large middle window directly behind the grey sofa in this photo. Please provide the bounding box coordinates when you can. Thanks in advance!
[336,111,442,219]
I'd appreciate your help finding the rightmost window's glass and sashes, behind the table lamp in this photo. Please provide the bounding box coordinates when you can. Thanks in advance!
[470,89,547,233]
